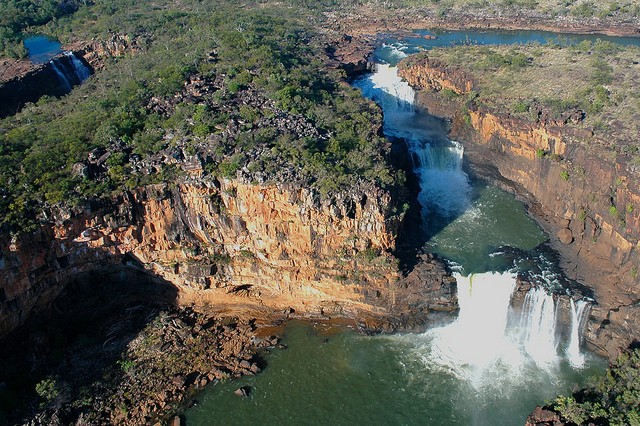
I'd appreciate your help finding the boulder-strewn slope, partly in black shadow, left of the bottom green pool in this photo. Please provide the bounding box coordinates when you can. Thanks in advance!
[0,301,284,425]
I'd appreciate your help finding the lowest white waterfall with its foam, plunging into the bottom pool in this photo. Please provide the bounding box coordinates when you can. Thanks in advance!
[415,272,588,390]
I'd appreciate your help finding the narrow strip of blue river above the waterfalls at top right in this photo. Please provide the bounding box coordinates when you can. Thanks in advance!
[374,30,640,65]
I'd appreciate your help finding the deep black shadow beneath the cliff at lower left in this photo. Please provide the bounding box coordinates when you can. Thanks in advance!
[0,262,178,425]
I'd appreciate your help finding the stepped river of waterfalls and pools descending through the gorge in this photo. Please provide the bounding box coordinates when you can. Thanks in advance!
[185,30,604,425]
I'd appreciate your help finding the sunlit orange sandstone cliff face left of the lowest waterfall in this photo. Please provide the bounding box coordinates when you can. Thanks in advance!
[0,180,457,335]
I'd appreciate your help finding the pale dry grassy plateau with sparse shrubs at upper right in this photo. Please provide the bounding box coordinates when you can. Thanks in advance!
[404,40,640,148]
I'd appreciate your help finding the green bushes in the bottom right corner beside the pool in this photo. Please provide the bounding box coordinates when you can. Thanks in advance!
[551,349,640,426]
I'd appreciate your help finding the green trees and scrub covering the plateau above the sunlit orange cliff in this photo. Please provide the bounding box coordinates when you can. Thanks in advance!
[0,0,398,231]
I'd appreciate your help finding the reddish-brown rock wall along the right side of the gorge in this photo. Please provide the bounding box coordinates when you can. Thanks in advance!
[400,59,640,357]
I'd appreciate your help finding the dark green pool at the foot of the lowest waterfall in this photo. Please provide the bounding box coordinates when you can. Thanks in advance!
[184,321,601,426]
